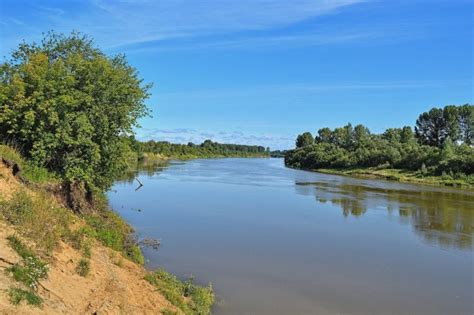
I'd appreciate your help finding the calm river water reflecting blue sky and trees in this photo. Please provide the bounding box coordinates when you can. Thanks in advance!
[109,159,474,315]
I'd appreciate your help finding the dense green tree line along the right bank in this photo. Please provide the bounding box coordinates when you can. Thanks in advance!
[285,104,474,178]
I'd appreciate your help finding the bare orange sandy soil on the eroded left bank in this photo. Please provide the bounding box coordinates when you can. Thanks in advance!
[0,162,179,315]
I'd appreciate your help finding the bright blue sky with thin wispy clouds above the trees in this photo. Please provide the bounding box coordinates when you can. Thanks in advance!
[0,0,474,149]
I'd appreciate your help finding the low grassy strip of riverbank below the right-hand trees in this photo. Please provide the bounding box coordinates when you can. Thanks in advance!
[307,168,474,189]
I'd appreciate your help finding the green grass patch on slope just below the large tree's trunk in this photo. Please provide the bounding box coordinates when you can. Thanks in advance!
[84,210,145,264]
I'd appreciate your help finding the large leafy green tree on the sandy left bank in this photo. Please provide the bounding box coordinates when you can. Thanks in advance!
[0,33,150,191]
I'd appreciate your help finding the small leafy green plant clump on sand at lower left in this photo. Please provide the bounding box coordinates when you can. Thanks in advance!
[6,235,48,290]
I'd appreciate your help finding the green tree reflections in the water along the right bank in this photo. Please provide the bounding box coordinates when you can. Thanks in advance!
[296,182,474,249]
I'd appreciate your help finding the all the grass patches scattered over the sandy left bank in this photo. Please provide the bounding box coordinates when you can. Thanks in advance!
[0,145,214,315]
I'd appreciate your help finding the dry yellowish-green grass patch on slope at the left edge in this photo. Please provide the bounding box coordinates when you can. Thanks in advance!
[0,189,72,254]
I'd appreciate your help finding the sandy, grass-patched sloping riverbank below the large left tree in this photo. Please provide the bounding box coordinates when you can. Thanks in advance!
[0,145,214,314]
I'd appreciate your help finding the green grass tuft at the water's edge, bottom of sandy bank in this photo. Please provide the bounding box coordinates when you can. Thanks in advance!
[145,270,214,315]
